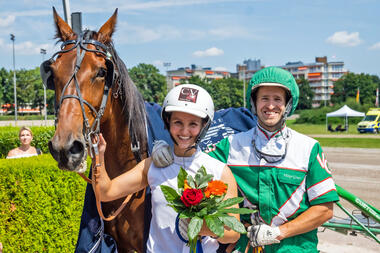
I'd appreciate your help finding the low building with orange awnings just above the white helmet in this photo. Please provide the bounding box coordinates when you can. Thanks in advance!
[166,64,231,90]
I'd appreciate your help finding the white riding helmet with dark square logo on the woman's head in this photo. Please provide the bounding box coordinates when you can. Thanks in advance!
[161,84,214,144]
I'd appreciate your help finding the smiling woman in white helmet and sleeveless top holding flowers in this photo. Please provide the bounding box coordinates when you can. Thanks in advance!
[93,84,240,253]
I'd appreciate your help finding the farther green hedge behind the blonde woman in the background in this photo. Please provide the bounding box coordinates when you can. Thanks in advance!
[0,126,55,158]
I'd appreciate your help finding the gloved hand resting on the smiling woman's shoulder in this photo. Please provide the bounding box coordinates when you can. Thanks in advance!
[152,140,174,168]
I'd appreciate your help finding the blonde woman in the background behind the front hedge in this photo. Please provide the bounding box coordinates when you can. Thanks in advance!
[7,126,41,159]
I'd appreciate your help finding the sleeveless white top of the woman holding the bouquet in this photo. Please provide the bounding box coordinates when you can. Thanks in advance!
[147,148,225,253]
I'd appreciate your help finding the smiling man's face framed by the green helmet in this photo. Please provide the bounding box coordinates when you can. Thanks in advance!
[256,86,286,132]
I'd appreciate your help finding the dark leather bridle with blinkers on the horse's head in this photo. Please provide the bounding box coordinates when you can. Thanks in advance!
[40,33,120,157]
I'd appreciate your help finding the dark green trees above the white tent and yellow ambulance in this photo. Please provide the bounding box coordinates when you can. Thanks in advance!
[331,73,379,104]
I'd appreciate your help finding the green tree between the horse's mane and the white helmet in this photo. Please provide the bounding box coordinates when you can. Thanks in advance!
[129,63,167,103]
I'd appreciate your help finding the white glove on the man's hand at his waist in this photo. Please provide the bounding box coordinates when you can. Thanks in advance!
[247,224,281,247]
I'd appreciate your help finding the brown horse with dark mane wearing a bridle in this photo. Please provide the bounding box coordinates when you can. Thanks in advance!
[41,8,147,252]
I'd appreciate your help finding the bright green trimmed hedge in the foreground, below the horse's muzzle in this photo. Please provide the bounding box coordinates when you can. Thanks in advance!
[0,154,86,252]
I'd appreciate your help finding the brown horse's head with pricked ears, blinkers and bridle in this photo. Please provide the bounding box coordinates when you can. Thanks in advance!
[40,8,117,172]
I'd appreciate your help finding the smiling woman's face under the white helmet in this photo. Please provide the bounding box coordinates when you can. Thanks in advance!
[169,112,203,151]
